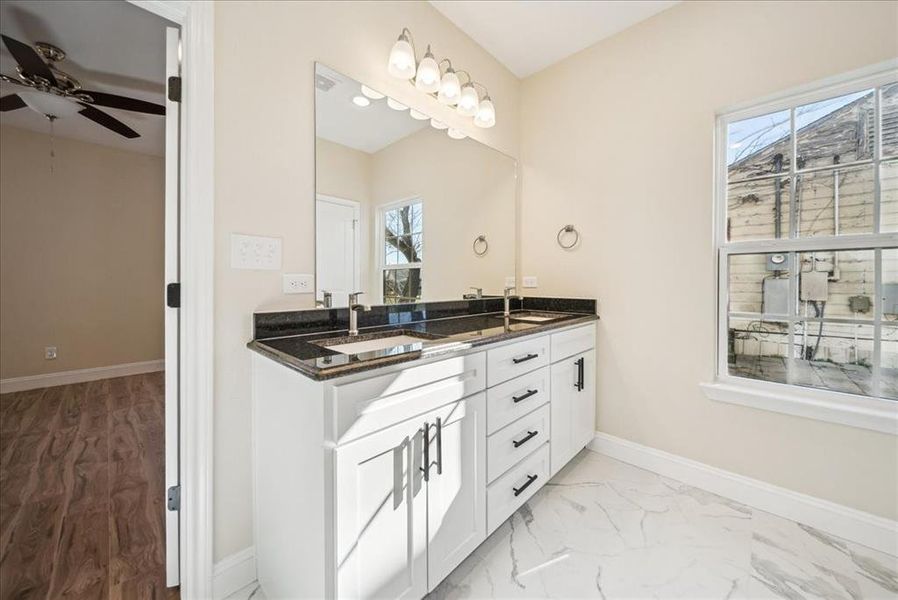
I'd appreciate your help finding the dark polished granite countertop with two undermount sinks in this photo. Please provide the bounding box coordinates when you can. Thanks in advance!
[247,305,598,381]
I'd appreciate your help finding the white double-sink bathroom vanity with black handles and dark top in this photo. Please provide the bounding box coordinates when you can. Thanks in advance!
[249,299,597,598]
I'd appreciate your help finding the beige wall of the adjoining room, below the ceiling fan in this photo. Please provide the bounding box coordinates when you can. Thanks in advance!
[0,126,165,379]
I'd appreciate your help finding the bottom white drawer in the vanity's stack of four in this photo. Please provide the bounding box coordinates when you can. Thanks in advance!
[486,444,549,535]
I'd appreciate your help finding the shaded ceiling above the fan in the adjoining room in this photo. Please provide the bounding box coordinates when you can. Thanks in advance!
[0,0,172,155]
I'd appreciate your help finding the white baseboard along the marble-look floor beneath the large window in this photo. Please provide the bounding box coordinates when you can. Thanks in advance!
[589,431,898,556]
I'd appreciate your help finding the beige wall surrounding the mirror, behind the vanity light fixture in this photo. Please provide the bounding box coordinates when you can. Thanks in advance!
[214,2,519,560]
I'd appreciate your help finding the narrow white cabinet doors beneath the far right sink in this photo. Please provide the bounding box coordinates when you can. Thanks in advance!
[551,350,596,475]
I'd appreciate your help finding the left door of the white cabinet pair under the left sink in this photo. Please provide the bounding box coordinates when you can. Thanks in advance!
[336,418,427,598]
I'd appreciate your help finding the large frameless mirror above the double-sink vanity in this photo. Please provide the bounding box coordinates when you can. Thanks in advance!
[315,64,517,307]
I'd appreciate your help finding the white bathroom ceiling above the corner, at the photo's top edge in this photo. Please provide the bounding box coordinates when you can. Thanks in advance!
[430,0,679,78]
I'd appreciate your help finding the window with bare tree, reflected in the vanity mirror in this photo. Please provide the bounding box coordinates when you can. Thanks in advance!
[379,198,424,304]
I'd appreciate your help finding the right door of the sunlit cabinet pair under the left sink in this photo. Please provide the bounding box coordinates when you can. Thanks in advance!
[425,393,486,590]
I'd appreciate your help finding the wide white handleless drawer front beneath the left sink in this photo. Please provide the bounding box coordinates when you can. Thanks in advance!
[331,352,486,444]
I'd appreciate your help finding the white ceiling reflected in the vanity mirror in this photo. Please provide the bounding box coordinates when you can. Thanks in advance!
[315,64,430,154]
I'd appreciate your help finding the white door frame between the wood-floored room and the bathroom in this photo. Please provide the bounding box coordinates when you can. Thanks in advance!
[128,0,215,600]
